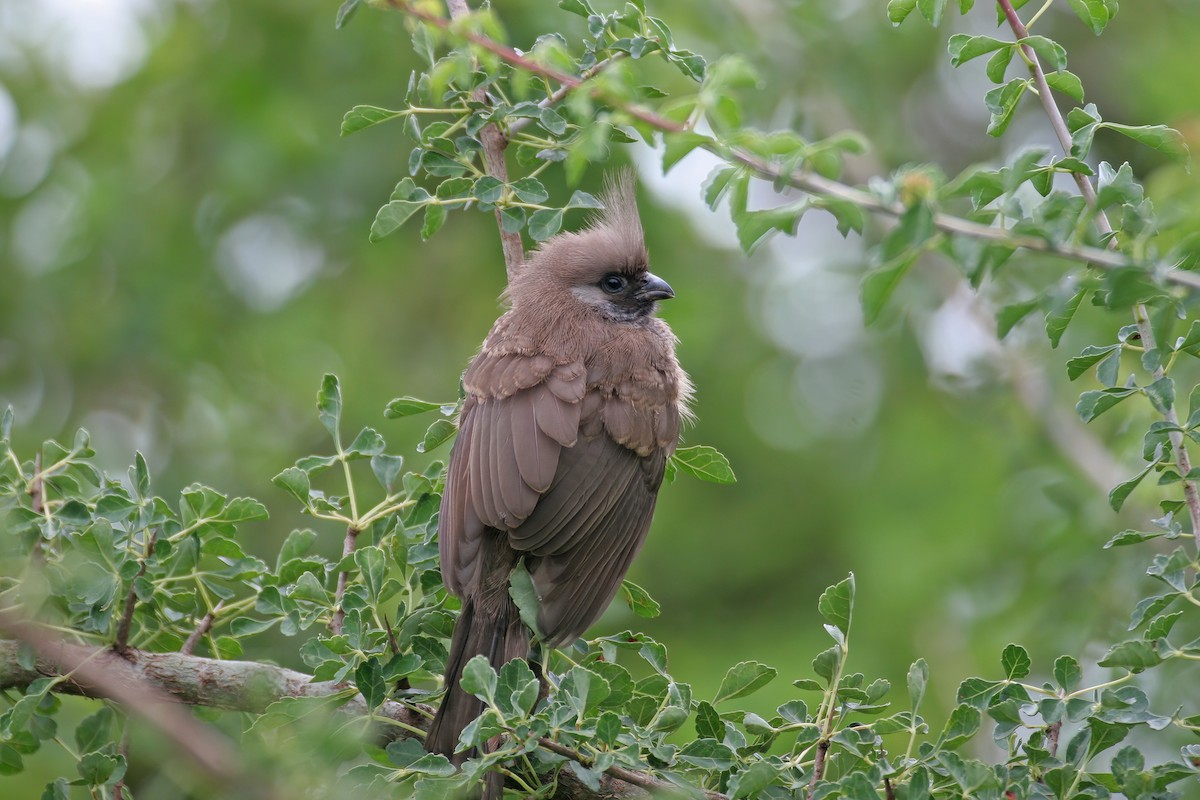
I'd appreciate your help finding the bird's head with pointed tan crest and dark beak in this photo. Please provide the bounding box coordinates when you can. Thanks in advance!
[508,172,674,321]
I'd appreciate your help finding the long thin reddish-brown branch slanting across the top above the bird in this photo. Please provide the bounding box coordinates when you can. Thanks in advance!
[388,0,1200,292]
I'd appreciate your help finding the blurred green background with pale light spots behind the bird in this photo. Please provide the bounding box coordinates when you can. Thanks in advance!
[0,0,1200,786]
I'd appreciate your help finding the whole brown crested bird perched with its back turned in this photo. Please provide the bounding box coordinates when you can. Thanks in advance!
[426,174,691,756]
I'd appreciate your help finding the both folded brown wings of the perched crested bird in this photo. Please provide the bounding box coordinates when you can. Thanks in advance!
[439,350,679,645]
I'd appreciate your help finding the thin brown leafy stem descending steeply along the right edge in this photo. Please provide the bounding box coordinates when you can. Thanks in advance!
[997,0,1200,547]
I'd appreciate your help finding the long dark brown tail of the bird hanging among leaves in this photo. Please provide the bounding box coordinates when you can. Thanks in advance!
[425,595,529,762]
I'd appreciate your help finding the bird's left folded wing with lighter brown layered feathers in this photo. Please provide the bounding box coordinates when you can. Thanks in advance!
[438,350,586,595]
